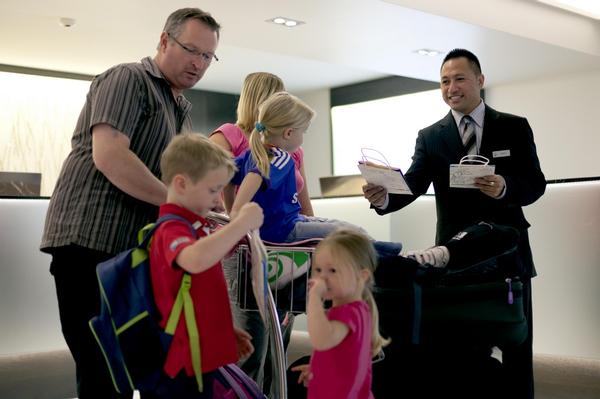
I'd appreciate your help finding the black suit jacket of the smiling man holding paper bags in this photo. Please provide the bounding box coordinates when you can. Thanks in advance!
[376,106,546,277]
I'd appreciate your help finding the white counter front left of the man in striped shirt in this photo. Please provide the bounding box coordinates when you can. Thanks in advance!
[0,199,66,356]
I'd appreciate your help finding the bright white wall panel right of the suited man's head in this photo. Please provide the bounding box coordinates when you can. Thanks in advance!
[486,70,600,179]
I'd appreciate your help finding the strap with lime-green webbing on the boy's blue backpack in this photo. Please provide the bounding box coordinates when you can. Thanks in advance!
[138,214,204,392]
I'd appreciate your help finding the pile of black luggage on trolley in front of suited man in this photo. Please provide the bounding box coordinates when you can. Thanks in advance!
[373,223,528,347]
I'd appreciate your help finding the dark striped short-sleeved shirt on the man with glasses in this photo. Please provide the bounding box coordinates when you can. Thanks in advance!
[40,57,192,254]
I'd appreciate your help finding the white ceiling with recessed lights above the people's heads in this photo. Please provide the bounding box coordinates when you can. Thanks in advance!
[0,0,600,93]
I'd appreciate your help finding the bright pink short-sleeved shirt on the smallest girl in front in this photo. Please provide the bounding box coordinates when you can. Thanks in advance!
[308,301,373,399]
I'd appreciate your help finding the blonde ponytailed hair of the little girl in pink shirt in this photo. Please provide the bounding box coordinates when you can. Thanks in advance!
[316,229,390,356]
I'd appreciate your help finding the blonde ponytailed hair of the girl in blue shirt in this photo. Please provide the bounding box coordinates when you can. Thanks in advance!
[250,91,315,177]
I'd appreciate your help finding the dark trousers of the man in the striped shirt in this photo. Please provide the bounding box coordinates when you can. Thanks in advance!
[50,245,132,399]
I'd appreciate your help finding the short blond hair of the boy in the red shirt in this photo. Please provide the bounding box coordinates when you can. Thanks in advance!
[160,133,237,185]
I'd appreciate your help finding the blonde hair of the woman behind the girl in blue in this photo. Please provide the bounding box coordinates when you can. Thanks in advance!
[236,72,285,133]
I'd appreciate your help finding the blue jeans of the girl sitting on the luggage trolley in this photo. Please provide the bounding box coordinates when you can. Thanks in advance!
[285,216,402,257]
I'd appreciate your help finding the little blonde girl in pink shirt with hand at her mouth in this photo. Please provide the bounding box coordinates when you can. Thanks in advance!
[294,230,389,399]
